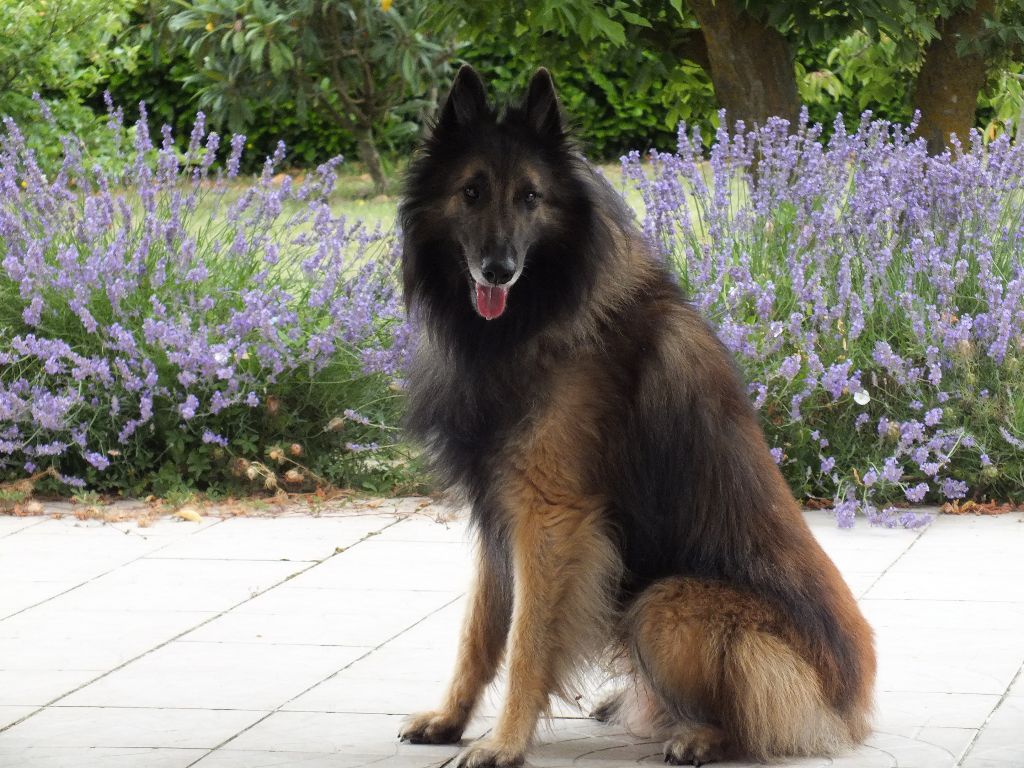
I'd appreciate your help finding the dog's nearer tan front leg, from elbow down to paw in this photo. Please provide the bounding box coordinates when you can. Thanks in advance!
[459,505,620,768]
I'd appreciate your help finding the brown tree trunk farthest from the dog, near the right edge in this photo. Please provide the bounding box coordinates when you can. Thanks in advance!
[913,0,995,155]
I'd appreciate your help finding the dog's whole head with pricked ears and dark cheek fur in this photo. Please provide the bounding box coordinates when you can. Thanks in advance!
[400,66,585,319]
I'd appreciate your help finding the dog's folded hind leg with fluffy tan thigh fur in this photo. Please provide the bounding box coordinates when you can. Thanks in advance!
[628,578,854,765]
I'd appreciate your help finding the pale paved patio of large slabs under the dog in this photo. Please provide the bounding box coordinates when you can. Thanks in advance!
[0,500,1024,768]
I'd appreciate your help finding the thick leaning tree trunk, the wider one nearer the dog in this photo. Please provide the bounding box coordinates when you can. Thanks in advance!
[689,0,800,128]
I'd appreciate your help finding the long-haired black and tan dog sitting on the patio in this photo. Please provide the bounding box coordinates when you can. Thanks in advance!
[398,67,876,768]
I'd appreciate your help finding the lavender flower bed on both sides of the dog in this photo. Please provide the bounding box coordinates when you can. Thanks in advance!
[0,105,1024,525]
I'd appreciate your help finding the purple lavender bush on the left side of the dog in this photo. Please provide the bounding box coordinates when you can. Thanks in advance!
[0,102,406,494]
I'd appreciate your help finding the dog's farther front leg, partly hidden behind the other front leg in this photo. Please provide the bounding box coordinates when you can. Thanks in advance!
[398,542,512,744]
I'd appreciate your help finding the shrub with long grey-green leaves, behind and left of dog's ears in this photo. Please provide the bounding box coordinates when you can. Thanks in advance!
[166,0,452,185]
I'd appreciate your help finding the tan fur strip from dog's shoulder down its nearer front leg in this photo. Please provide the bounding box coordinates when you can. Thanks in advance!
[470,369,622,764]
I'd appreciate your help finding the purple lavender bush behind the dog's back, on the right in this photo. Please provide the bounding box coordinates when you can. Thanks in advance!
[624,115,1024,525]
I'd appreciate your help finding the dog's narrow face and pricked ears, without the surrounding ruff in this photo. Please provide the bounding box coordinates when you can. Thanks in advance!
[434,67,562,319]
